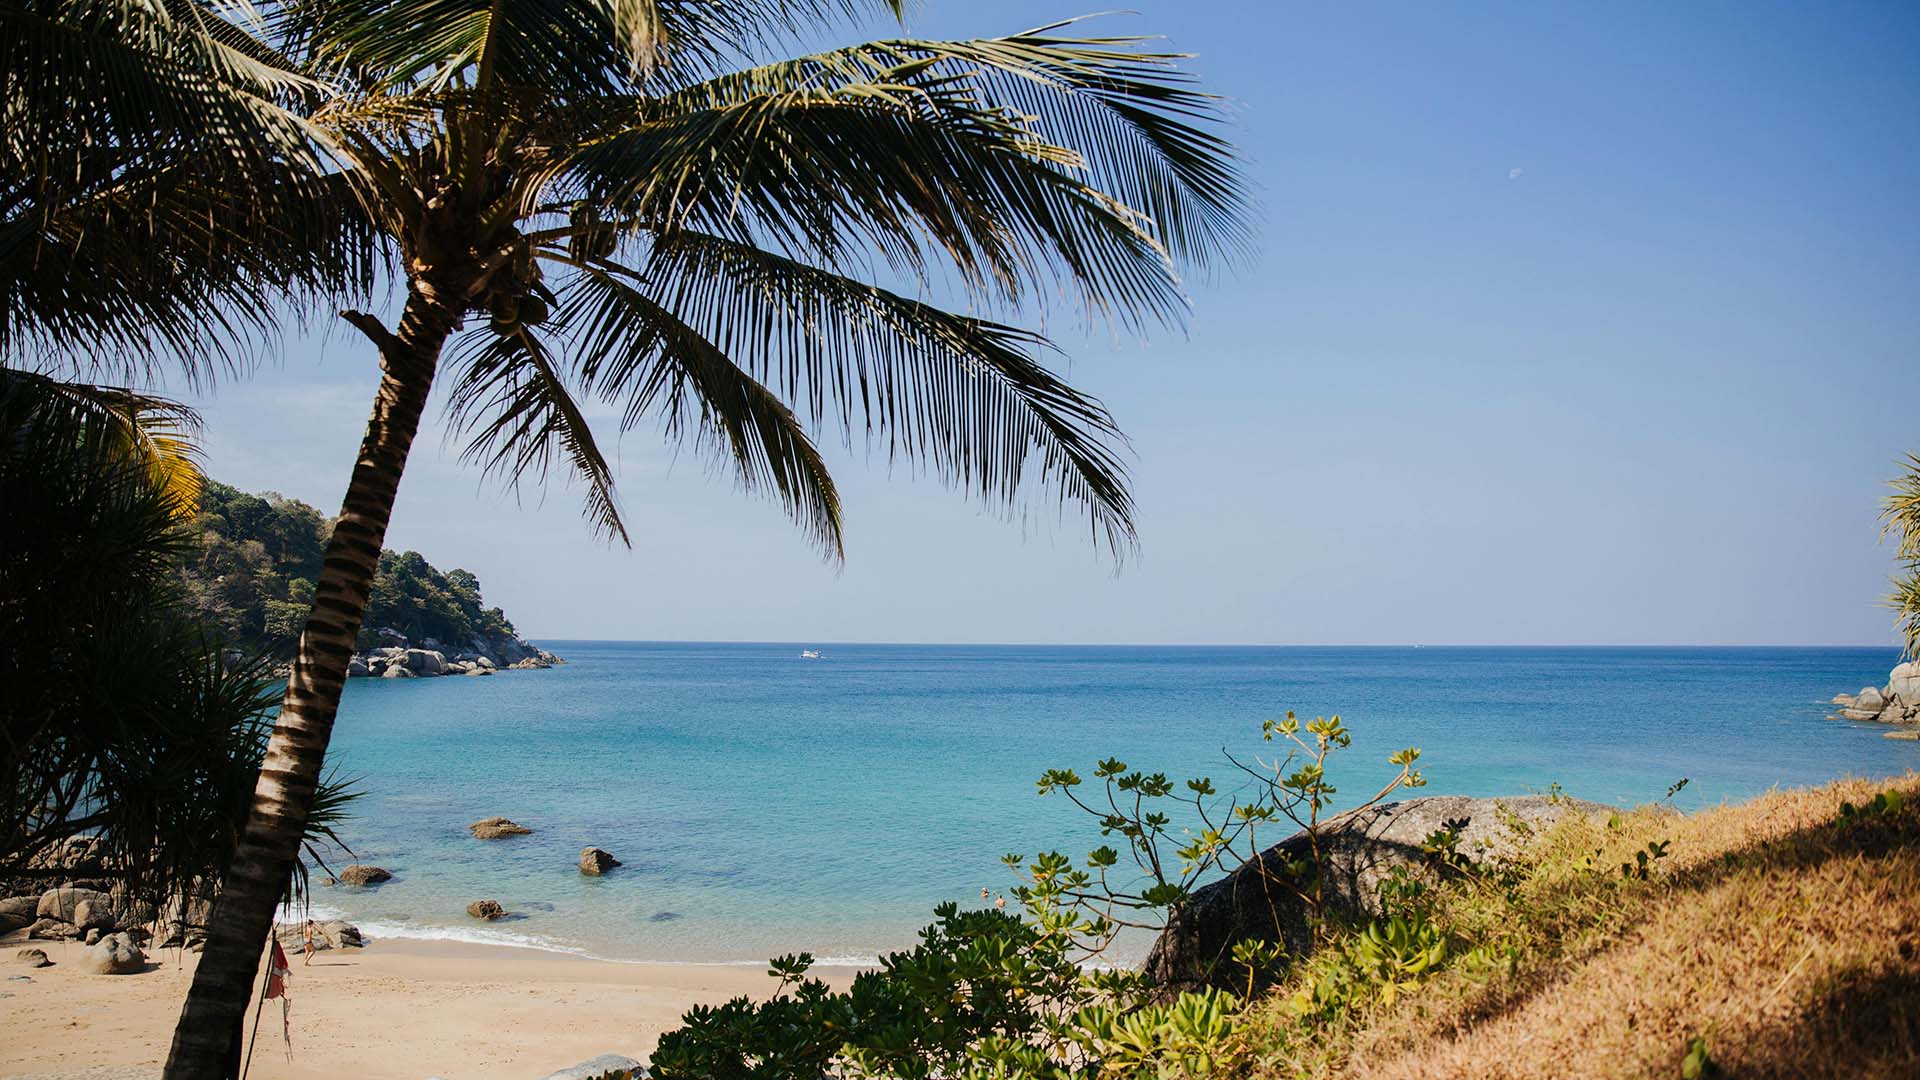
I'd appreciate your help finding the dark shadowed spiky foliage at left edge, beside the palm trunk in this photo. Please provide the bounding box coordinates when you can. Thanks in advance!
[0,373,346,903]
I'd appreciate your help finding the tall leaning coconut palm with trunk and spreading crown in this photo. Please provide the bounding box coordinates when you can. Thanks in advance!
[139,0,1244,1078]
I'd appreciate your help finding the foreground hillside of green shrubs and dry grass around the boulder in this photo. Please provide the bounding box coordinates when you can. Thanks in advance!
[653,719,1920,1080]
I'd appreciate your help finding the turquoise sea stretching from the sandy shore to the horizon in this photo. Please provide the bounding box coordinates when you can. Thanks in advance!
[315,642,1920,963]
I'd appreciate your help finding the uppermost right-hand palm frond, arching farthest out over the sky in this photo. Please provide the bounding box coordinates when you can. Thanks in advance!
[555,21,1246,325]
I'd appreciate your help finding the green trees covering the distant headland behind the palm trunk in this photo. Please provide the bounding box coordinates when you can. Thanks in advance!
[184,482,515,659]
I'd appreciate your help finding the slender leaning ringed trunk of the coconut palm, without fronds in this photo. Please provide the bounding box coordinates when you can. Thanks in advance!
[165,290,459,1080]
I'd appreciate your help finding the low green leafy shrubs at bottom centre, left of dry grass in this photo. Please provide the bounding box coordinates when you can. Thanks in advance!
[651,903,1244,1080]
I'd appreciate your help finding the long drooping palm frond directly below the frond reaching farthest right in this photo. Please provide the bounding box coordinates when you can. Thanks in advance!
[580,231,1135,553]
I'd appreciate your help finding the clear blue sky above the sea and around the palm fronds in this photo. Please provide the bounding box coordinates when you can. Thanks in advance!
[187,0,1920,644]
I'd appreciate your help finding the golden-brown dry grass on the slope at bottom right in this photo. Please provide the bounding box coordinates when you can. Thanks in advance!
[1256,774,1920,1080]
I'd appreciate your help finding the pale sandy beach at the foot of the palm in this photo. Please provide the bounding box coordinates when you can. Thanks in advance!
[0,940,854,1080]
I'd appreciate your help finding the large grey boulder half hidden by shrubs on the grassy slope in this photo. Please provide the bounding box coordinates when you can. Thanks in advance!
[1144,796,1609,990]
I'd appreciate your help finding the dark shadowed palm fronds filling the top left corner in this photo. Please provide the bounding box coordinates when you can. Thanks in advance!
[0,0,380,380]
